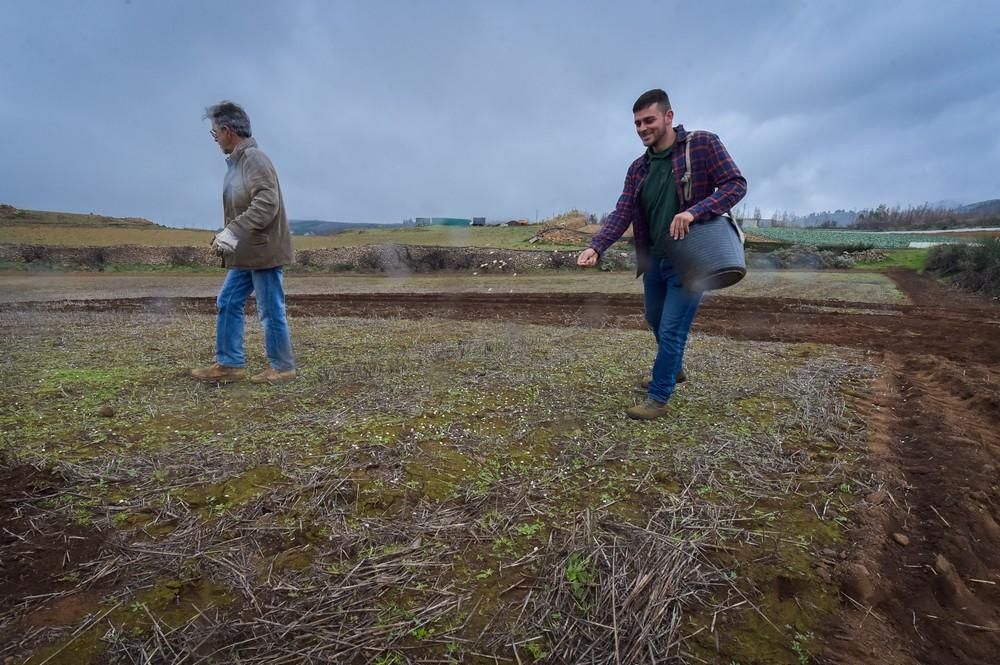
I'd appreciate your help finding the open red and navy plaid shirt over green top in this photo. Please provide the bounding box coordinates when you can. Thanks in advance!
[590,125,747,275]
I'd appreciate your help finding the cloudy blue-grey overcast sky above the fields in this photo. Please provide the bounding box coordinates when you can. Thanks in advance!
[0,0,1000,227]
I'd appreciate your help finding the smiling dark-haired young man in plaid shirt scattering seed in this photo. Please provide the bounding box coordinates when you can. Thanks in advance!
[577,90,747,420]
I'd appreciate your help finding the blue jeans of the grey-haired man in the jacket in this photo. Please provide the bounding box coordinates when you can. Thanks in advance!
[215,266,295,371]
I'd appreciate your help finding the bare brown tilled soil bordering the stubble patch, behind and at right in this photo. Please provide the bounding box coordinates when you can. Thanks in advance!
[0,272,1000,665]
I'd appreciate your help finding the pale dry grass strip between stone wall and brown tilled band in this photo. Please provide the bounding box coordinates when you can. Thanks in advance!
[0,269,905,303]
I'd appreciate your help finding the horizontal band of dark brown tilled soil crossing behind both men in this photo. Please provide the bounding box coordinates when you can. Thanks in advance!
[0,284,1000,364]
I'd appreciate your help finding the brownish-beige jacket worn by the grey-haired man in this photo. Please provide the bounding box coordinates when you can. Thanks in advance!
[222,138,293,270]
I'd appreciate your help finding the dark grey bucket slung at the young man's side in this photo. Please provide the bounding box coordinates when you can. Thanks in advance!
[666,217,747,291]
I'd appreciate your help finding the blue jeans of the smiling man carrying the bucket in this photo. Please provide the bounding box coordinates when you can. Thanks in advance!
[642,258,702,402]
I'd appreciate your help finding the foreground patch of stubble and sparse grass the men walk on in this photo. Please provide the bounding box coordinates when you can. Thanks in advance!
[0,313,873,665]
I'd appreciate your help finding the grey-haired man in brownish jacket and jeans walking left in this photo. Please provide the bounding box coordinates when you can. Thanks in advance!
[191,102,295,383]
